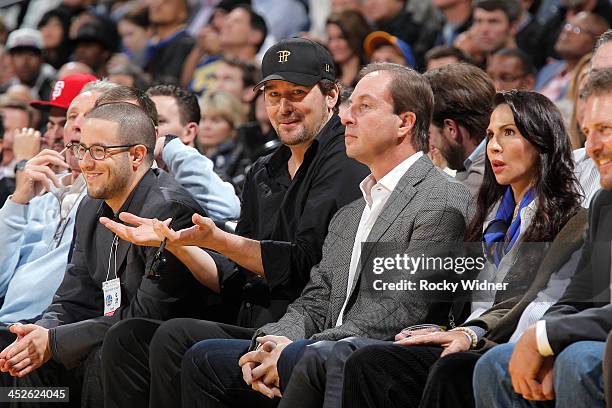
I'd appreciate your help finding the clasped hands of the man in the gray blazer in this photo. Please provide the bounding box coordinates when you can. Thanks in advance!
[238,336,292,398]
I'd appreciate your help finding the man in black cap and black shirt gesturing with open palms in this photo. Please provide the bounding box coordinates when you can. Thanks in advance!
[103,39,368,408]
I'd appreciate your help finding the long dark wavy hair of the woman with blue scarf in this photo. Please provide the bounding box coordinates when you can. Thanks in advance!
[466,90,582,242]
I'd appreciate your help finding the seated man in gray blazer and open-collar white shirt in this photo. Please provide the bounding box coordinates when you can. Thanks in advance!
[181,63,470,407]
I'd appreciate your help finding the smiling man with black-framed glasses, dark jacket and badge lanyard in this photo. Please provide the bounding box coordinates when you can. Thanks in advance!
[0,102,218,405]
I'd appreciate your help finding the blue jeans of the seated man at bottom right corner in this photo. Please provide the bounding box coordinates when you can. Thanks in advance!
[474,341,605,408]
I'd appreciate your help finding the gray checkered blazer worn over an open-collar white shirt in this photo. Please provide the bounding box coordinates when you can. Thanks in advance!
[255,155,470,340]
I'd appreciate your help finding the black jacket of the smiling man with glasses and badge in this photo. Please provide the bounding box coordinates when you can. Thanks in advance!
[37,169,220,367]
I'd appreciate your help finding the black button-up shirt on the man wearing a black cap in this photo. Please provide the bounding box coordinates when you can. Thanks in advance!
[214,115,369,327]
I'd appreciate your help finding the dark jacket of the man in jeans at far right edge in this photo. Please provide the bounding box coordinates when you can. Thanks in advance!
[544,190,612,354]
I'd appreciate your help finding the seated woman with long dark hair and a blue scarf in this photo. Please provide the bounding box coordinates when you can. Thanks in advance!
[343,90,586,408]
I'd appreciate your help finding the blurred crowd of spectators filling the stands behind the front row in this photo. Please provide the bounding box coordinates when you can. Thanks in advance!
[0,0,612,201]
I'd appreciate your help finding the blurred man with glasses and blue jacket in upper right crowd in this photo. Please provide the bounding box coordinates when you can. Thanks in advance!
[534,11,609,102]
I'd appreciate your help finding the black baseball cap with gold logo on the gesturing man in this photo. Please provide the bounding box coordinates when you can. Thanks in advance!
[253,38,336,91]
